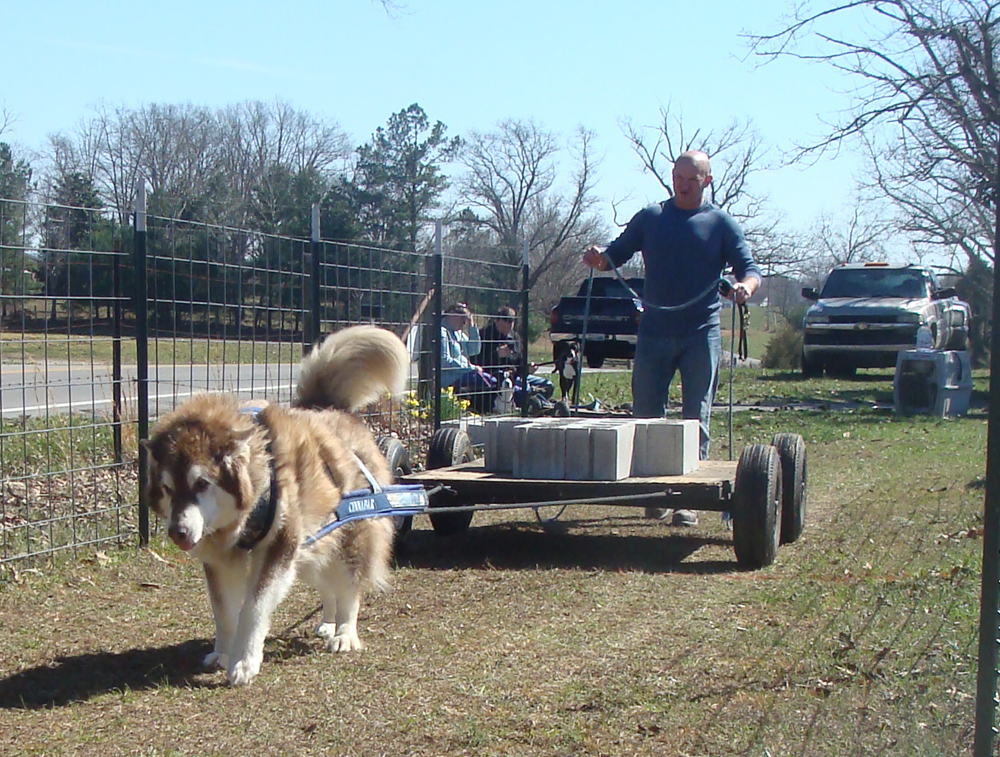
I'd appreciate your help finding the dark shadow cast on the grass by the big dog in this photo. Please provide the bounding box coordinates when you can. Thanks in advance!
[0,639,221,710]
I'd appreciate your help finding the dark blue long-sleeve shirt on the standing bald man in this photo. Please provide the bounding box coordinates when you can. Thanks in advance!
[605,199,763,336]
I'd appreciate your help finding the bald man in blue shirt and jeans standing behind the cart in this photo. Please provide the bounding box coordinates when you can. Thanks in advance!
[583,150,763,526]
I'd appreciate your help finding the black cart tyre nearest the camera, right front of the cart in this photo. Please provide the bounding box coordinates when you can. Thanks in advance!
[733,444,781,569]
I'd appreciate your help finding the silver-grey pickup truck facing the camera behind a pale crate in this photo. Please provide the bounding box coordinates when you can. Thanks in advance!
[802,263,972,378]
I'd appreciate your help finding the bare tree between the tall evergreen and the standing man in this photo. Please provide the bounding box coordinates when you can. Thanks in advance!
[457,119,607,300]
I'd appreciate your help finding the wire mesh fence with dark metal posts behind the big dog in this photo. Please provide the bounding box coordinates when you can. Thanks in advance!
[0,195,527,580]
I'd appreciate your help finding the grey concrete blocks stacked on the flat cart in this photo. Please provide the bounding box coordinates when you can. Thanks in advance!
[484,418,699,481]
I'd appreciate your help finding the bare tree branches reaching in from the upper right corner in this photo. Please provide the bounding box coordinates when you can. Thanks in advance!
[750,0,1000,270]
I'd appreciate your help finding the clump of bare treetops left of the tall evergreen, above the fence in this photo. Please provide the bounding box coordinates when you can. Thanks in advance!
[50,102,350,225]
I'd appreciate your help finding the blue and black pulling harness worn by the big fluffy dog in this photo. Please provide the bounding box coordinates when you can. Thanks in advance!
[236,407,428,550]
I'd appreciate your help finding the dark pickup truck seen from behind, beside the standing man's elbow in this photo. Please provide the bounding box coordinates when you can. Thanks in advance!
[549,276,643,368]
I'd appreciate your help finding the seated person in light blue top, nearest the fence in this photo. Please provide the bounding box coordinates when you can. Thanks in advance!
[441,302,497,415]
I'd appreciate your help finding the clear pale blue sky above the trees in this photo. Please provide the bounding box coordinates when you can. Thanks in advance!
[0,0,858,241]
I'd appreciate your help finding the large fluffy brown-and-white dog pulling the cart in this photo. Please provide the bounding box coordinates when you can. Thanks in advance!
[143,326,409,686]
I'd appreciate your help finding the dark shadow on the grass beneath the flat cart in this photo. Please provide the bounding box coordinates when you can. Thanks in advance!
[396,513,742,574]
